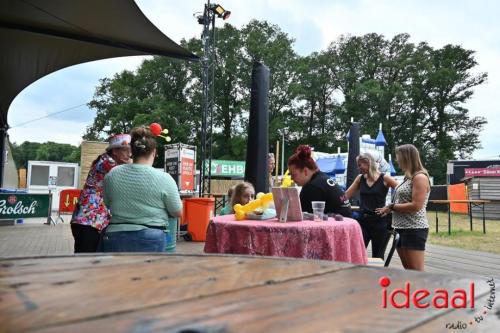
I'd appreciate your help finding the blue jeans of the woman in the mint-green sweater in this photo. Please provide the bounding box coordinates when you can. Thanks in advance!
[102,228,165,252]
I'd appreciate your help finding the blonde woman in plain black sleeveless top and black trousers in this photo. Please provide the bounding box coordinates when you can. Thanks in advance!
[346,153,397,259]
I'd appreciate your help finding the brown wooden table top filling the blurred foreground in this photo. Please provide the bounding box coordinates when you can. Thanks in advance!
[0,254,500,333]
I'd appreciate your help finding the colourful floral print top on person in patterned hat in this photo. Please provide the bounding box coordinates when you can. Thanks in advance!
[71,153,117,231]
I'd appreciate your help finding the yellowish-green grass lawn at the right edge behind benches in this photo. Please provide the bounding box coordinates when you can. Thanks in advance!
[427,212,500,254]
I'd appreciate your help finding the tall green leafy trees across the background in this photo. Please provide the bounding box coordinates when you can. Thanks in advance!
[84,20,487,183]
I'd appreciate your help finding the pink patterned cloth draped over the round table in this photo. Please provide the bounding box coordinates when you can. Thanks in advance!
[205,215,367,264]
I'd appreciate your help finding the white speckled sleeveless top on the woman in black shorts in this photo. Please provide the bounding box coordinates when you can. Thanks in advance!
[392,172,429,229]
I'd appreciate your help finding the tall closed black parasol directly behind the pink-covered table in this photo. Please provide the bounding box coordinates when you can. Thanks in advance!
[245,61,270,193]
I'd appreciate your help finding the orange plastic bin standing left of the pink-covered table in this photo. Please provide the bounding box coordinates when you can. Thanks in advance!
[182,198,215,242]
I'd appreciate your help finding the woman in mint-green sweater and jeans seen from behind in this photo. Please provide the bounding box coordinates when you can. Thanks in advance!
[103,127,182,252]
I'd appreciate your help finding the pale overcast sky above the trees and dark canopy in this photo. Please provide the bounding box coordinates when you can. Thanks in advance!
[4,0,500,158]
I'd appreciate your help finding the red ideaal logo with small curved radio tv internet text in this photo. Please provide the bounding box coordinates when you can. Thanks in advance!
[379,276,495,329]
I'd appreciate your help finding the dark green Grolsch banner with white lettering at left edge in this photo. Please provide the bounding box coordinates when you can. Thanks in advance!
[0,193,49,220]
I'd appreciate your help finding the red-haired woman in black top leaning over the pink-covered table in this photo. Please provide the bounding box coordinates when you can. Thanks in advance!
[288,145,352,217]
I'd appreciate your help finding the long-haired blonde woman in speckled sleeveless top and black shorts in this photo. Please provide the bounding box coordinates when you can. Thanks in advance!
[377,144,431,271]
